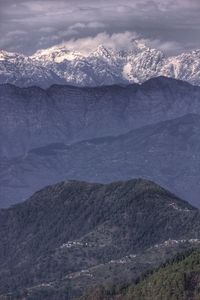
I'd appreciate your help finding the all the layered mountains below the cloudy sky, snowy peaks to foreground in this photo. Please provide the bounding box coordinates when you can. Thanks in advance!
[0,32,200,300]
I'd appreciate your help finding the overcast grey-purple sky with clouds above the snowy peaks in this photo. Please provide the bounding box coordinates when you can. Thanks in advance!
[0,0,200,55]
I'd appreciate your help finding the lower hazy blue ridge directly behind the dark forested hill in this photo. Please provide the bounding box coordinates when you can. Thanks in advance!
[0,114,200,206]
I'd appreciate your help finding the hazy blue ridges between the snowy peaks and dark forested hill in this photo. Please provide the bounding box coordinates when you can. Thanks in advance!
[0,77,200,207]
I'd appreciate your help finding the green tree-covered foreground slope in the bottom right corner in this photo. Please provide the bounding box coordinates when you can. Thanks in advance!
[81,249,200,300]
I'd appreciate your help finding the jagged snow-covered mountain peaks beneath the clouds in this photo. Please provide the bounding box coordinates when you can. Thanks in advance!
[0,41,200,87]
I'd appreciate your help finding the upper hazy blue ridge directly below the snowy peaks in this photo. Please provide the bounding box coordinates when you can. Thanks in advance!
[0,77,200,157]
